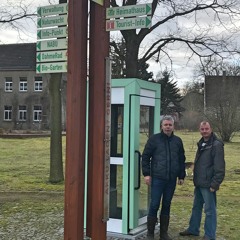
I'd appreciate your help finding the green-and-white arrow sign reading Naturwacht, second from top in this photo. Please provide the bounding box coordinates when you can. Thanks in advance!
[37,15,67,28]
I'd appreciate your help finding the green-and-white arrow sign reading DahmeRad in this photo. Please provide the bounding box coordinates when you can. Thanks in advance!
[36,50,67,62]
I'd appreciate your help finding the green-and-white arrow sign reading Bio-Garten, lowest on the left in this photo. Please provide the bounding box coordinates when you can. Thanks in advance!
[36,62,67,73]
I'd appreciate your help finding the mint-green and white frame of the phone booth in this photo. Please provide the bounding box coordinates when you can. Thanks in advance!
[107,78,161,235]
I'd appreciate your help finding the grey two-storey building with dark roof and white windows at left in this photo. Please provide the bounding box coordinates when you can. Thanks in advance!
[0,43,50,130]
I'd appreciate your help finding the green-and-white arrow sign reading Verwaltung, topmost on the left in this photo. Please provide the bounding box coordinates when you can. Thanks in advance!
[37,3,68,17]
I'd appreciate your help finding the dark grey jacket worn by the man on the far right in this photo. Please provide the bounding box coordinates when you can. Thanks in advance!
[193,133,225,190]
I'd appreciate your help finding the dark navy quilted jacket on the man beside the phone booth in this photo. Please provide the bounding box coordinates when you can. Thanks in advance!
[142,132,185,180]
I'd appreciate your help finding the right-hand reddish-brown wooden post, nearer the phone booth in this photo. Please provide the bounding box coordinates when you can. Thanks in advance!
[86,0,109,240]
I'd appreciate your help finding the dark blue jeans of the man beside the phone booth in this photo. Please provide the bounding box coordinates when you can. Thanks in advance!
[148,178,176,217]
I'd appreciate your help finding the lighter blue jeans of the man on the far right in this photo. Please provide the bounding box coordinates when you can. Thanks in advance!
[188,187,217,239]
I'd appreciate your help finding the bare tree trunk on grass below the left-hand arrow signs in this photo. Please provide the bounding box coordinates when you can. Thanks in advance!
[49,73,64,183]
